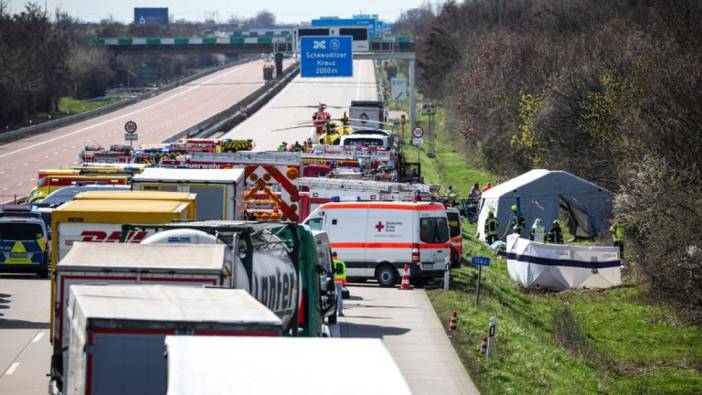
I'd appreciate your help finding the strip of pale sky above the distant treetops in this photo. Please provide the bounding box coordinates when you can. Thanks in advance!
[6,0,434,22]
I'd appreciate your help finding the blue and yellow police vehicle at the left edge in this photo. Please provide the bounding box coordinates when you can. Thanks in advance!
[0,205,49,278]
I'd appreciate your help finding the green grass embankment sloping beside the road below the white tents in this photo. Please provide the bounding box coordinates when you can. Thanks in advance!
[405,106,702,394]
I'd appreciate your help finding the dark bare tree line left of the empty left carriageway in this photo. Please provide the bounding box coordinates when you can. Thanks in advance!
[0,0,275,130]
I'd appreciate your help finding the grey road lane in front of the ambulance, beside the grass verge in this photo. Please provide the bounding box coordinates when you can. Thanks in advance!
[339,283,479,395]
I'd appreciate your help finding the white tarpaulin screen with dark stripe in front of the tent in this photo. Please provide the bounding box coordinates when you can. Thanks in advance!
[507,234,622,291]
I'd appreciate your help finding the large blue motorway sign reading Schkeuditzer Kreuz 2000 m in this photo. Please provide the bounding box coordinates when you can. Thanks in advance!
[300,36,353,78]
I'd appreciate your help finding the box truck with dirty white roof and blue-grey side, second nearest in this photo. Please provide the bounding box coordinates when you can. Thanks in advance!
[64,285,282,395]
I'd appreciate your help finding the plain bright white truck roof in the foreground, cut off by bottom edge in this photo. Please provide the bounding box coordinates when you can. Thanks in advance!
[166,336,411,395]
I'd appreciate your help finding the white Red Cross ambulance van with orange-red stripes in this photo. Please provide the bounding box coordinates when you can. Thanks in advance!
[305,202,451,287]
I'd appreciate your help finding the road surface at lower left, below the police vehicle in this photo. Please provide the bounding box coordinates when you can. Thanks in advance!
[0,274,51,395]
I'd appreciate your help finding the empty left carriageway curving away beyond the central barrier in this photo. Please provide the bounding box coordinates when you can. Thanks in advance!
[0,60,276,202]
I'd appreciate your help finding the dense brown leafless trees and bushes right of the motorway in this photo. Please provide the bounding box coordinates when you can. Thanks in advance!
[395,0,702,313]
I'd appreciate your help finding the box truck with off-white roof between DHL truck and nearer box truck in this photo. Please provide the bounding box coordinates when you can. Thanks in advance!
[51,242,233,390]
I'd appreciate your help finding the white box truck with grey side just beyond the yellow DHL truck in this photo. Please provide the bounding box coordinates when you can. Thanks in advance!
[132,167,246,220]
